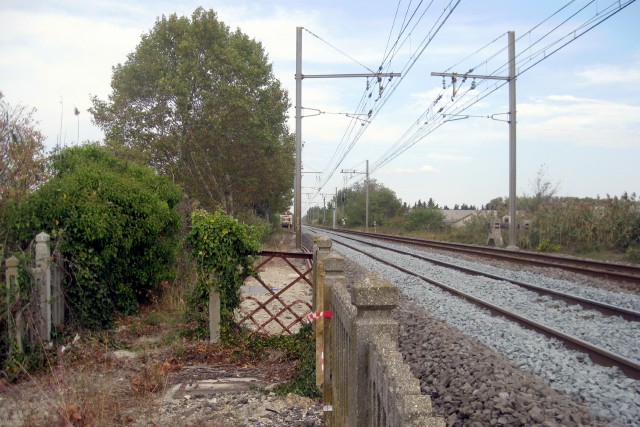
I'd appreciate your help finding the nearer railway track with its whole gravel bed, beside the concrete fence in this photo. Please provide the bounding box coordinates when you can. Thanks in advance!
[305,227,640,426]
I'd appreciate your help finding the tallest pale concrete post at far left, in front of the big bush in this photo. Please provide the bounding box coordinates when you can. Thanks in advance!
[35,232,51,342]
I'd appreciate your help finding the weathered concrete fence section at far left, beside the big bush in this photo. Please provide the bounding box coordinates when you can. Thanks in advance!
[5,233,64,352]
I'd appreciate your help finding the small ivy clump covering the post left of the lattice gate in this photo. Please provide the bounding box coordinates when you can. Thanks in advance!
[187,209,263,339]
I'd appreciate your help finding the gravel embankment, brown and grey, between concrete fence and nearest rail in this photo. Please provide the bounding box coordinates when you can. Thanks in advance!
[306,234,640,426]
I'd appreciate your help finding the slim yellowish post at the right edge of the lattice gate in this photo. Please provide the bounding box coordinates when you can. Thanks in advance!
[313,235,331,390]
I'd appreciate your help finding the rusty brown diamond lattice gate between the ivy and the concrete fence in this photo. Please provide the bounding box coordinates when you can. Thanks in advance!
[236,251,313,335]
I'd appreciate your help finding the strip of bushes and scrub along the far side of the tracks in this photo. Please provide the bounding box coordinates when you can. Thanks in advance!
[303,181,640,262]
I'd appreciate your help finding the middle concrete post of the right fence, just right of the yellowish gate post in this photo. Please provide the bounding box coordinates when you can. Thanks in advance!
[316,252,345,426]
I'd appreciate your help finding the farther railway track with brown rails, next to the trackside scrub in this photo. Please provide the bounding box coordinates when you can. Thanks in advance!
[319,228,640,286]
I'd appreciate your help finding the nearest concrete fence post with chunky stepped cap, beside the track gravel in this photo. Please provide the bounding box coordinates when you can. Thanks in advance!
[348,273,398,426]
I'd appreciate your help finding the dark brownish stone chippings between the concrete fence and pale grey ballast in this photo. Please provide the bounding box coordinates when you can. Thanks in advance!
[396,300,606,426]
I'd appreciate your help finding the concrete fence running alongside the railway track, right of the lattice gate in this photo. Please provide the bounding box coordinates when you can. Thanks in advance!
[314,236,445,427]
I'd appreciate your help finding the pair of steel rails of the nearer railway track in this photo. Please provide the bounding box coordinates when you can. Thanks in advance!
[310,230,640,379]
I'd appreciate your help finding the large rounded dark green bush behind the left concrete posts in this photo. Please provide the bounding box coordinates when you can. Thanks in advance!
[12,145,182,329]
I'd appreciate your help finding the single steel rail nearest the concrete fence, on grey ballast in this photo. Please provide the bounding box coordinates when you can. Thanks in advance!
[324,234,640,380]
